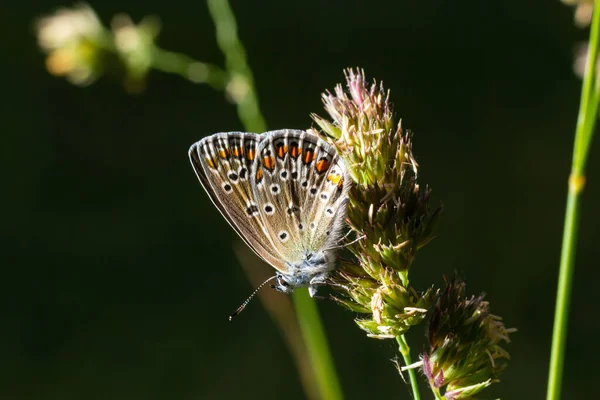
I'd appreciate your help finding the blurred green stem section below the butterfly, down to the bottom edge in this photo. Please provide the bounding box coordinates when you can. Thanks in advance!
[292,288,343,400]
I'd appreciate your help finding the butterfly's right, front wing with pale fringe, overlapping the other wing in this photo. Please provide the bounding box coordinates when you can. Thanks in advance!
[251,130,350,265]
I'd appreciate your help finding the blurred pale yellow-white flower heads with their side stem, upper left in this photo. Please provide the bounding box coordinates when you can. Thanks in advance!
[35,4,220,92]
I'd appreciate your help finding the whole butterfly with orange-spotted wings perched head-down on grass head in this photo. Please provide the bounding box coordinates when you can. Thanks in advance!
[189,129,350,313]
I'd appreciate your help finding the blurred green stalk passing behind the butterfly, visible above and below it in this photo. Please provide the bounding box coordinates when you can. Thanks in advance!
[207,0,343,400]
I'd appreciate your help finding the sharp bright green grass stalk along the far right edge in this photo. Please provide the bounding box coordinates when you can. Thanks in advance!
[546,3,600,400]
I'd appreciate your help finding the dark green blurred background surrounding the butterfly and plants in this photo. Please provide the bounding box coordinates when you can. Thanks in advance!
[0,0,600,400]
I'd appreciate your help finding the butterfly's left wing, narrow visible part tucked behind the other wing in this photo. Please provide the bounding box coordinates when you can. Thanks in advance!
[189,132,287,273]
